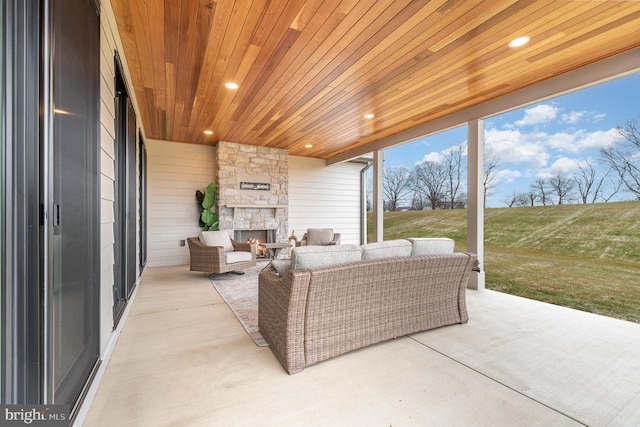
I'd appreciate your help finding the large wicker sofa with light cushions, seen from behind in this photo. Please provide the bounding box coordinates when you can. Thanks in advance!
[258,239,476,374]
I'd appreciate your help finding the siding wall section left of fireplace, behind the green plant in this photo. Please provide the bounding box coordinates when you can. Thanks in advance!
[145,140,216,267]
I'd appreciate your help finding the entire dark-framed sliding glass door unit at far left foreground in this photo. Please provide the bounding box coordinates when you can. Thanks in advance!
[0,0,100,412]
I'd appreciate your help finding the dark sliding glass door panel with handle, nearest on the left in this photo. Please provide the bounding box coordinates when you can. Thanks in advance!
[45,0,100,410]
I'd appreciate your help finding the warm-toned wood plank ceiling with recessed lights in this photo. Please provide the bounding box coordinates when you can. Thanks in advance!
[111,0,640,159]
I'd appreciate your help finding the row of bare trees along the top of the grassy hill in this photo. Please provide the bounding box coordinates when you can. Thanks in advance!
[376,117,640,211]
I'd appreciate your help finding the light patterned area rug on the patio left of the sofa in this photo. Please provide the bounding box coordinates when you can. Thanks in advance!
[210,263,269,347]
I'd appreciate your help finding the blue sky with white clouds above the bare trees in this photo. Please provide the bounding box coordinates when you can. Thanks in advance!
[384,73,640,207]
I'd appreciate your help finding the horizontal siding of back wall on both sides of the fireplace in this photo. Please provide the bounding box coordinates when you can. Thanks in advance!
[146,152,361,266]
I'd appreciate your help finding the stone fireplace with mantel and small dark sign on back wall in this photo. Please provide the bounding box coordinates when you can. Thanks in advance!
[217,141,289,243]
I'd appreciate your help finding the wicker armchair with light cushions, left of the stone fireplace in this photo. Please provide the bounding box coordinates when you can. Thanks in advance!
[187,231,256,274]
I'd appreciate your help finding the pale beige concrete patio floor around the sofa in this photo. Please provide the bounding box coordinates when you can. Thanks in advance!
[76,266,640,427]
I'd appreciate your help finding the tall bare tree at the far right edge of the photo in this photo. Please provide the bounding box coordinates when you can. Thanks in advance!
[601,117,640,200]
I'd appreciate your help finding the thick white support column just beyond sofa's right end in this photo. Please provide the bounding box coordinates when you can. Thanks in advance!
[467,120,484,290]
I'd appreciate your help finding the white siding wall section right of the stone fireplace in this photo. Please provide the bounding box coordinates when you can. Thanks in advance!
[289,156,363,244]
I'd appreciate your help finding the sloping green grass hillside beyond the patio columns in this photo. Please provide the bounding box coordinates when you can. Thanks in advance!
[369,202,640,323]
